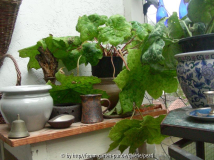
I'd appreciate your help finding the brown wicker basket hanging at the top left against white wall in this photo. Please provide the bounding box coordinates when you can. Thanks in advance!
[0,0,22,67]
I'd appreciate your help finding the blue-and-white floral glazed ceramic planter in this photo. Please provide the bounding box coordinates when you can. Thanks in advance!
[175,50,214,108]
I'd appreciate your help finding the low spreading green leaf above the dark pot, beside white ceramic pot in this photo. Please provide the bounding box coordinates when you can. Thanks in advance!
[47,72,108,104]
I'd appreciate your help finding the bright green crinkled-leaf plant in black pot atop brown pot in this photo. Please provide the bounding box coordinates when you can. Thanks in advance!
[76,14,155,108]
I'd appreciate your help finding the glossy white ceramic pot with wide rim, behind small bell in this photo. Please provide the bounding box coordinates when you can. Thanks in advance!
[0,85,53,132]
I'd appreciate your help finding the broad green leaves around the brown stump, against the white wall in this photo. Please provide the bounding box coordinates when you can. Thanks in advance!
[19,35,82,70]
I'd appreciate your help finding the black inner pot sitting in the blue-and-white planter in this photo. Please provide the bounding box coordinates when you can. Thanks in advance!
[179,34,214,53]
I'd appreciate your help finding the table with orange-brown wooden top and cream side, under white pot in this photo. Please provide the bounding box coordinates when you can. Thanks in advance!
[0,110,167,160]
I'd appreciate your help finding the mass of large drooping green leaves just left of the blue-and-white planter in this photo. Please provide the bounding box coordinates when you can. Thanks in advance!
[115,17,181,114]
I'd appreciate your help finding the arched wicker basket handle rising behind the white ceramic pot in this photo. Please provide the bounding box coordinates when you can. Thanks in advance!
[0,54,21,124]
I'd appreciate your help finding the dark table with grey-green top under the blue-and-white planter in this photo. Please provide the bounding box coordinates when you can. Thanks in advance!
[161,107,214,159]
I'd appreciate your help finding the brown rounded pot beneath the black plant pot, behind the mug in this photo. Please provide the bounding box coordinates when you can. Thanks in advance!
[93,78,120,110]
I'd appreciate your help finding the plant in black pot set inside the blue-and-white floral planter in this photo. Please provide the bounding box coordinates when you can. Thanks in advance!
[171,0,214,108]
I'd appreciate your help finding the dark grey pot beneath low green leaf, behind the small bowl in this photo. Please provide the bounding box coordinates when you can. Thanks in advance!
[50,103,82,122]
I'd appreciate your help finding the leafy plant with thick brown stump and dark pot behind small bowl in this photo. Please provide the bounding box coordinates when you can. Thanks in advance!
[19,35,107,121]
